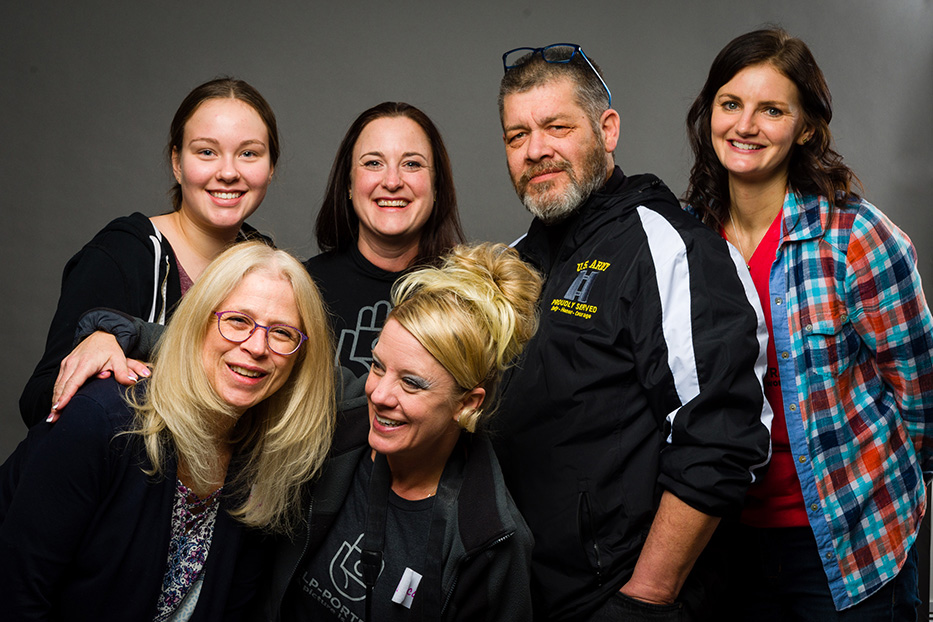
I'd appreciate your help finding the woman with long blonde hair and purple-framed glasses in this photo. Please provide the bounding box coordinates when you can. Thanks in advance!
[0,242,334,621]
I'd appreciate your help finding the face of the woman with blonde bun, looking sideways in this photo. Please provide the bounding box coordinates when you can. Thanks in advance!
[366,318,485,464]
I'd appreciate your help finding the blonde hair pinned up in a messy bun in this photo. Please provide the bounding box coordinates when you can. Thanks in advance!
[389,243,542,432]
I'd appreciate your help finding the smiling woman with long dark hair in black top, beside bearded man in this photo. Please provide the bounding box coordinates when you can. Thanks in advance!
[305,102,463,377]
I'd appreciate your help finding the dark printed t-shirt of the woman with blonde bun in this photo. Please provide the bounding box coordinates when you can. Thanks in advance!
[283,451,434,622]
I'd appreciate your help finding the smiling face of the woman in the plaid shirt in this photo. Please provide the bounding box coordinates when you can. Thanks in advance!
[710,64,812,187]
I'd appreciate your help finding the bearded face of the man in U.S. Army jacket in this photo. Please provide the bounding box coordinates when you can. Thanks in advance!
[502,78,619,222]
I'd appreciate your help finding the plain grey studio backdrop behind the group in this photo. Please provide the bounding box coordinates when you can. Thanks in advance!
[0,0,933,459]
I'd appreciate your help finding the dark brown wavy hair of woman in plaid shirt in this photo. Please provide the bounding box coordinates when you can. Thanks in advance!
[683,28,863,228]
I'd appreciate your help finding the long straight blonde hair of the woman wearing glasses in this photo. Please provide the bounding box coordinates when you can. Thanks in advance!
[130,242,335,532]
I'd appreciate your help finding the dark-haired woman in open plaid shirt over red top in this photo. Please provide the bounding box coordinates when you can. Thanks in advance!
[685,28,933,620]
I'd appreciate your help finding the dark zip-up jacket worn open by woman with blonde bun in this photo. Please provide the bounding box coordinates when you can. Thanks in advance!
[256,406,533,622]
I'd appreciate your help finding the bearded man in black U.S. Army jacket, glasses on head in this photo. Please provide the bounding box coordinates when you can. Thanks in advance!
[493,44,771,620]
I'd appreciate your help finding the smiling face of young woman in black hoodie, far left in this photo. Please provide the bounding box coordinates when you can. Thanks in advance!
[172,98,273,233]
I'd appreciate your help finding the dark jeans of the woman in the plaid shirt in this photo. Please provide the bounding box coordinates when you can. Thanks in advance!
[725,527,920,622]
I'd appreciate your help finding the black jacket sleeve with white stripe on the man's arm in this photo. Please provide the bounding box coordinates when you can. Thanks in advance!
[642,230,771,516]
